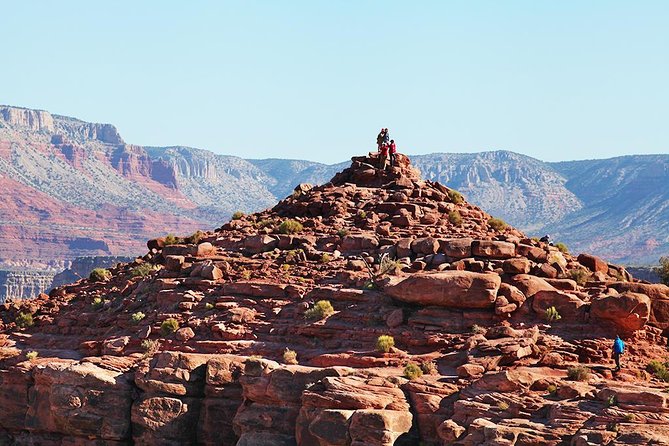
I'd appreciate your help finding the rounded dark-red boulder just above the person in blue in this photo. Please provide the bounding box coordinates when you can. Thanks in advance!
[590,291,650,333]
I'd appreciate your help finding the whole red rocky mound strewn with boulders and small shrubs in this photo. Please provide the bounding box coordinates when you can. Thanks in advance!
[0,154,669,446]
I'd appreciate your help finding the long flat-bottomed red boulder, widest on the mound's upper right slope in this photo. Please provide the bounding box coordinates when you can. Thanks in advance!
[385,271,501,308]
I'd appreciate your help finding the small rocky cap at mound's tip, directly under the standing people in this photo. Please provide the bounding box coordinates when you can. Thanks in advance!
[331,153,420,187]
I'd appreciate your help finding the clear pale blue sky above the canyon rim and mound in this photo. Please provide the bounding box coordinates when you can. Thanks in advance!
[0,0,669,163]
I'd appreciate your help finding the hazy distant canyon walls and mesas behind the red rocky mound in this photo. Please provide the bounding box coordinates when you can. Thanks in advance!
[0,106,669,263]
